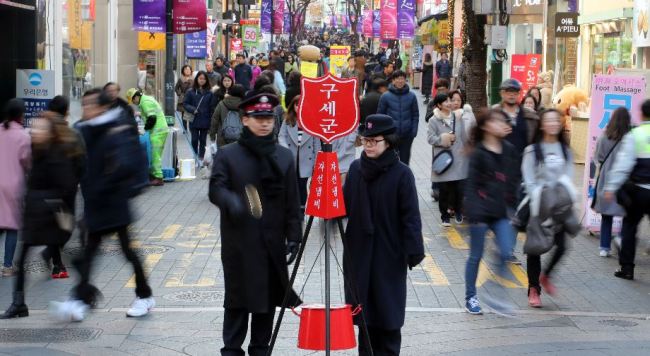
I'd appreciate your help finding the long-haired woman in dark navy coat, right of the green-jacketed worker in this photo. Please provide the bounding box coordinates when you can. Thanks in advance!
[183,71,216,161]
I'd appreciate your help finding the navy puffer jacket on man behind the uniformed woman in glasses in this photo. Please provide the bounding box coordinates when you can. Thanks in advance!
[377,84,420,139]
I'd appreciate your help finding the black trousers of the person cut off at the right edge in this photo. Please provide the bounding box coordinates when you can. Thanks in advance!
[618,187,650,269]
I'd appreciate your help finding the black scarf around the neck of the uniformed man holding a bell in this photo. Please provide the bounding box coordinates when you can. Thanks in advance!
[238,126,284,195]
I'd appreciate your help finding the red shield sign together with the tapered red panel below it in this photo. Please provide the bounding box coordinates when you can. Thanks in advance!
[298,73,359,219]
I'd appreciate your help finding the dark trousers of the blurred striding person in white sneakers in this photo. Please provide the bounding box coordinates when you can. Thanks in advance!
[73,226,152,305]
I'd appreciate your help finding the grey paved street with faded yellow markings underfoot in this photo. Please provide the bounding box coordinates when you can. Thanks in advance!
[0,93,650,355]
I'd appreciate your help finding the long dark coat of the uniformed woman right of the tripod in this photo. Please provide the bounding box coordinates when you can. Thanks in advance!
[343,160,424,330]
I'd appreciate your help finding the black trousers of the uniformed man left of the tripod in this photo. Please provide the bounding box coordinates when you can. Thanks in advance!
[221,309,275,356]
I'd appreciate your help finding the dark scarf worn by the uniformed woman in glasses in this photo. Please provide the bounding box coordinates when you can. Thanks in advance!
[358,148,399,235]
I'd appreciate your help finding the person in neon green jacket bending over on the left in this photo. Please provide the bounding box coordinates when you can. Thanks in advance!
[126,88,168,186]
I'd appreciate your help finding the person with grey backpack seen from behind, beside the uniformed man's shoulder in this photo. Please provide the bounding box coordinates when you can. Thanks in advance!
[210,84,245,147]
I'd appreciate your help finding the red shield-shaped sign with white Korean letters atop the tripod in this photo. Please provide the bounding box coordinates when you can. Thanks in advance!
[298,73,359,143]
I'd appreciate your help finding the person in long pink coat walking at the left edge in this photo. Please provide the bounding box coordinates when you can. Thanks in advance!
[0,99,32,277]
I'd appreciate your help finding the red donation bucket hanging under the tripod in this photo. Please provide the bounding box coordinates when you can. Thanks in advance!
[293,304,361,350]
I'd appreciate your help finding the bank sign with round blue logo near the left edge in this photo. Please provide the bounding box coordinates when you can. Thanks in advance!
[16,69,54,127]
